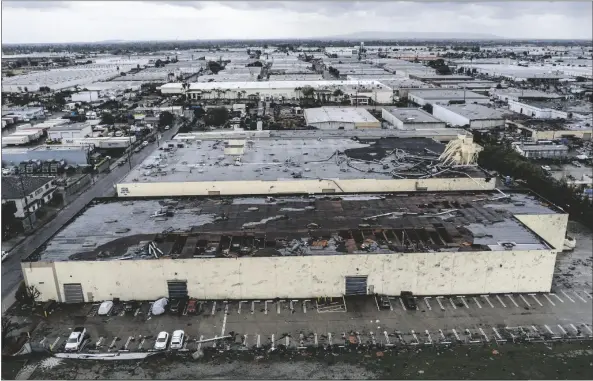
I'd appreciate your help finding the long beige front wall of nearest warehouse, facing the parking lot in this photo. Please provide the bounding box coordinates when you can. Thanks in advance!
[22,250,556,301]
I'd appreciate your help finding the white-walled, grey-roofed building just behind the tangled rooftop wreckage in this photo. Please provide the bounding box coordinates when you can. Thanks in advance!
[432,104,505,130]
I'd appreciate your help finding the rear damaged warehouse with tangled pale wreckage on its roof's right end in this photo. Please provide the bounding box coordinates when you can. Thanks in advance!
[117,129,495,197]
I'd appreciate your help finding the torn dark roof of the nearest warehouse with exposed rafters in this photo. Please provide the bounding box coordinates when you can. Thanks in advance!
[28,192,555,261]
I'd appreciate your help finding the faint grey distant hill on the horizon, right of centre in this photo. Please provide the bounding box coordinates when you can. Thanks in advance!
[325,32,504,40]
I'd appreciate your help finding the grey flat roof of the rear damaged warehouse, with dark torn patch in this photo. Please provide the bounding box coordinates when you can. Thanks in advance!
[121,135,484,183]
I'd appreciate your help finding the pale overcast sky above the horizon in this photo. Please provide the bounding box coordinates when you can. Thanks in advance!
[2,0,593,43]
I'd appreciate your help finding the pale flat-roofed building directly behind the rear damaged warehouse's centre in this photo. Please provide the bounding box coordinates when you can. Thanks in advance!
[304,107,381,130]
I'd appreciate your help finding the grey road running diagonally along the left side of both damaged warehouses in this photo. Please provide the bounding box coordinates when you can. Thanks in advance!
[2,124,179,312]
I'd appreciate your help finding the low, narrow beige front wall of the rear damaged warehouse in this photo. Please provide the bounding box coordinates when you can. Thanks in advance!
[117,178,495,197]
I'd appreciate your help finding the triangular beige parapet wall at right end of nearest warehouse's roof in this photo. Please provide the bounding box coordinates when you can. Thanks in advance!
[515,214,568,252]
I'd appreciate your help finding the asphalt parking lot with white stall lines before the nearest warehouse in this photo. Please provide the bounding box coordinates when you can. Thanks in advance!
[25,289,593,353]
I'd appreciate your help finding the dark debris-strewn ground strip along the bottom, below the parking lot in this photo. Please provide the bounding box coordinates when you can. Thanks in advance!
[3,342,593,380]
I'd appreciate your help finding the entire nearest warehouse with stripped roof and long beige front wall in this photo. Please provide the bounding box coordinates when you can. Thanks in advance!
[21,192,568,303]
